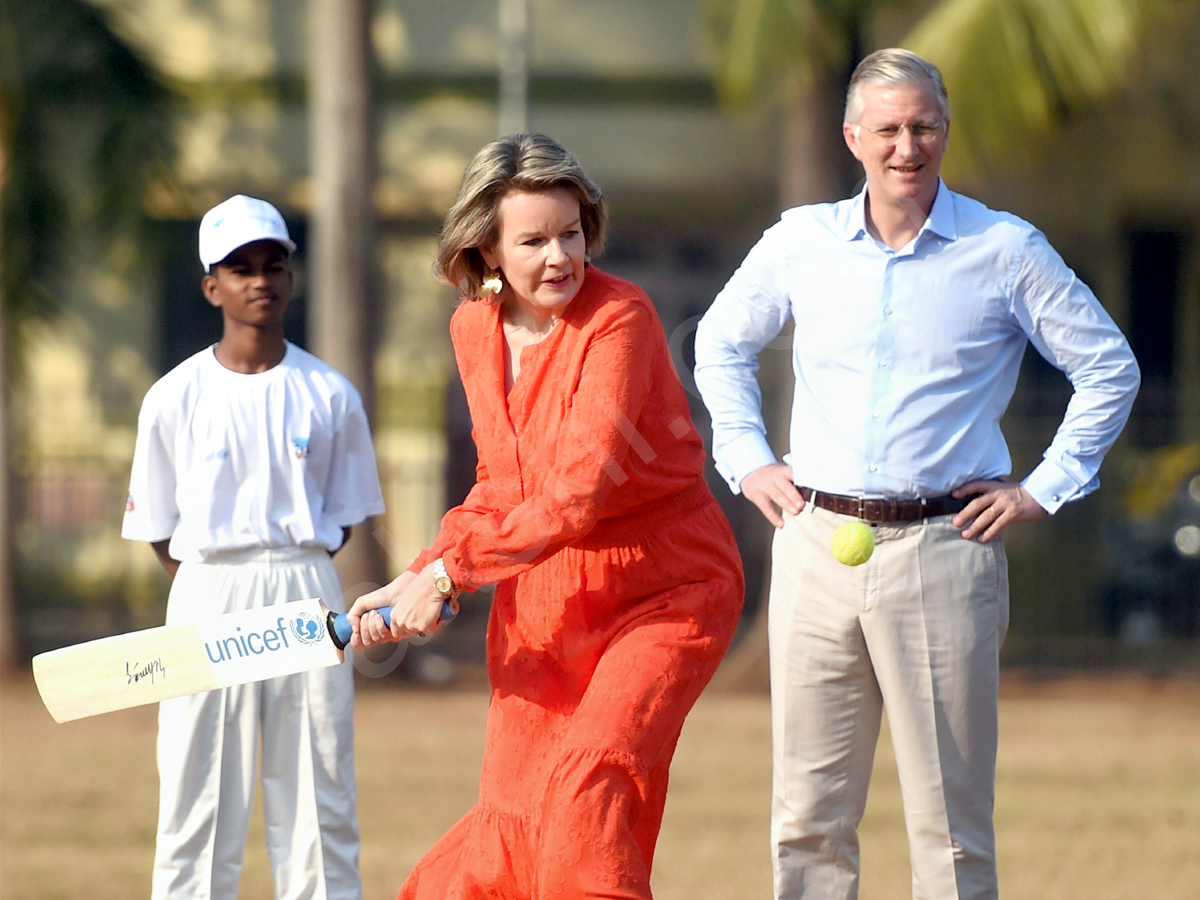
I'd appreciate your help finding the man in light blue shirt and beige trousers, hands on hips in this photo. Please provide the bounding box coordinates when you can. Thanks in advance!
[695,50,1139,900]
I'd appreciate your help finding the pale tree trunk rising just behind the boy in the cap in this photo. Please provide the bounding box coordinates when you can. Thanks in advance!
[308,0,386,600]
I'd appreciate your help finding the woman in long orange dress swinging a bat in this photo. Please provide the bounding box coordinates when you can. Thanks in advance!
[350,134,743,900]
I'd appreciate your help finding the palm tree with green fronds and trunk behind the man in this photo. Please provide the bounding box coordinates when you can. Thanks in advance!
[708,0,1169,688]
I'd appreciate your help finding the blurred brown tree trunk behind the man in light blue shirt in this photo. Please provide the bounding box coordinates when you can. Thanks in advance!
[714,66,860,692]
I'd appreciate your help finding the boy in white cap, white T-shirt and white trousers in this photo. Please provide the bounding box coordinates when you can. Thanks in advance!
[121,194,384,900]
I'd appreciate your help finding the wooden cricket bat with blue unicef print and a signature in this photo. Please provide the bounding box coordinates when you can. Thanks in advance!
[34,599,454,722]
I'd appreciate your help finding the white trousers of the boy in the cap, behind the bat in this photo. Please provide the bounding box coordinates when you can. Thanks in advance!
[151,547,362,900]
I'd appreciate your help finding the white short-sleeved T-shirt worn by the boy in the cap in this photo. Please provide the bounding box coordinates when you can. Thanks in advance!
[121,343,384,562]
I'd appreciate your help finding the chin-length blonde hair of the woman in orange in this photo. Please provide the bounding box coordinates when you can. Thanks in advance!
[433,134,608,300]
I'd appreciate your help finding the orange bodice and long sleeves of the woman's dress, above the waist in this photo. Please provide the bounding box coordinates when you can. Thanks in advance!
[414,269,703,589]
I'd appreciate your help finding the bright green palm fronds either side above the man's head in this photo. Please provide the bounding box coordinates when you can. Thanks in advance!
[708,0,1166,176]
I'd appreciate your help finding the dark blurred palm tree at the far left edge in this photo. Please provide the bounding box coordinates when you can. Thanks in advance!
[0,0,170,667]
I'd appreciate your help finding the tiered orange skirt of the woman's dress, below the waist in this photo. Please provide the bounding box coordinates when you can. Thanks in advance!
[400,499,744,900]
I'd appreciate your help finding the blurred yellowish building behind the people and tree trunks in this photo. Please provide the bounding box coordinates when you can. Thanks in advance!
[0,0,1200,665]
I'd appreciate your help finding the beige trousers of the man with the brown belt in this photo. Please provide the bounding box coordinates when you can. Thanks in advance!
[768,504,1008,900]
